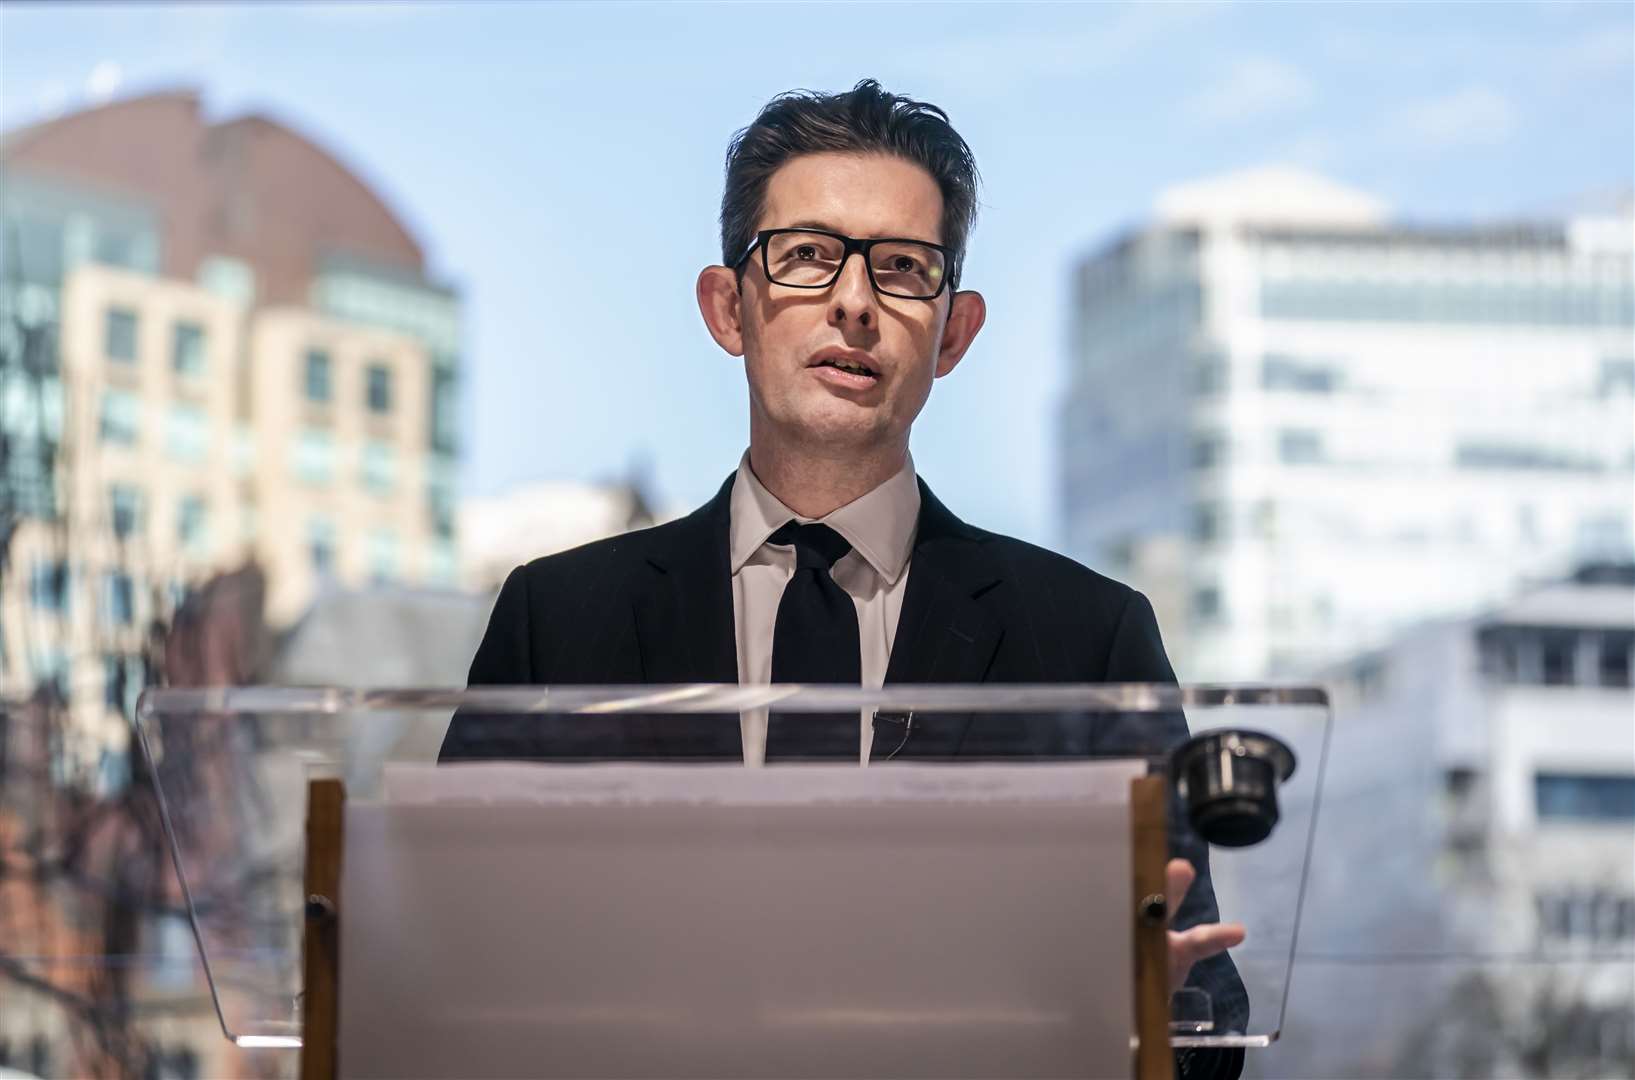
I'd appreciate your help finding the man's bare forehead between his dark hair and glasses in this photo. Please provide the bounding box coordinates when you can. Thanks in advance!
[757,154,942,240]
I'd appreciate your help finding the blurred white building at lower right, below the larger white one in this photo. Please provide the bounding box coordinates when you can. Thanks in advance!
[1251,564,1635,1078]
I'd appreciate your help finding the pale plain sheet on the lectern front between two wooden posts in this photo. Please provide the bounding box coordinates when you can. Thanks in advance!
[340,761,1145,1080]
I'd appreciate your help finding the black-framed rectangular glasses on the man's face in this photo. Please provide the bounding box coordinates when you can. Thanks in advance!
[732,229,953,301]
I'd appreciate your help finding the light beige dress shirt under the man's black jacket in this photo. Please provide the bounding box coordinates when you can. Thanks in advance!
[729,451,921,765]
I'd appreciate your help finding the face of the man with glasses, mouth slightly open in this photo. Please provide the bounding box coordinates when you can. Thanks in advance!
[700,154,981,456]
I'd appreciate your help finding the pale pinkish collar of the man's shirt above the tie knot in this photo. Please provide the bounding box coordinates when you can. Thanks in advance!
[729,451,921,585]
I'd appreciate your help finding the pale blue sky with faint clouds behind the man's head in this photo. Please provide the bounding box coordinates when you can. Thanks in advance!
[0,3,1635,544]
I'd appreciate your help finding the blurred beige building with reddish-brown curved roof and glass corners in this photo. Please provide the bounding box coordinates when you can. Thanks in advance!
[0,91,461,768]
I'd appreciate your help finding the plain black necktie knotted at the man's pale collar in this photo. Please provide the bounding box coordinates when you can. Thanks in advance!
[767,521,863,761]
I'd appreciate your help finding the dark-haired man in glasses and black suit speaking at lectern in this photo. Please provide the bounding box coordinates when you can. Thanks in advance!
[441,80,1248,1077]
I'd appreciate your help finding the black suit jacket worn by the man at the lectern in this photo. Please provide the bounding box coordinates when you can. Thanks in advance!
[440,475,1249,1077]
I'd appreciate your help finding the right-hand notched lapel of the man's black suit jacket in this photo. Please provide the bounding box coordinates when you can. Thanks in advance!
[870,480,1004,760]
